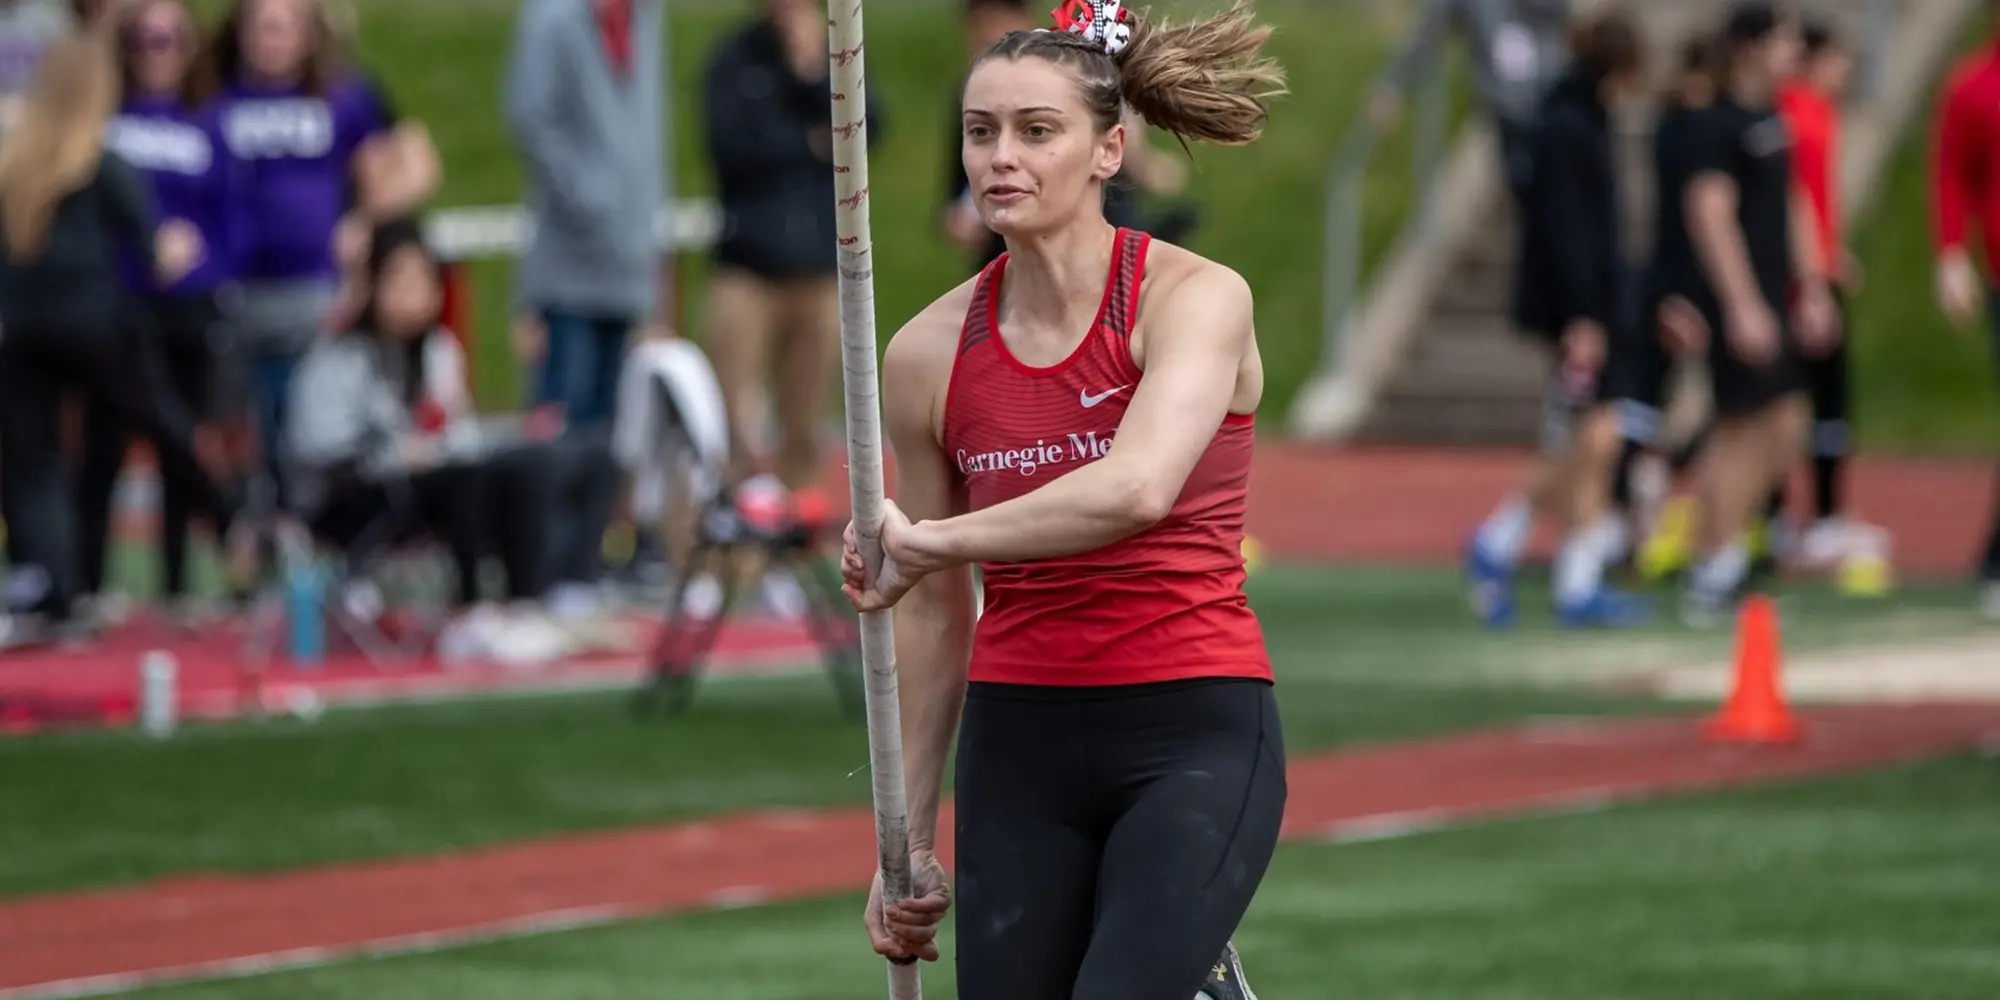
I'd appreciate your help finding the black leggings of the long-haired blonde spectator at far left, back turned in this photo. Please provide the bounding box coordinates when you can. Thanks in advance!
[0,310,234,620]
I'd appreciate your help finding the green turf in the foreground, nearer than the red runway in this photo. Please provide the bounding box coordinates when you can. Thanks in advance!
[121,756,2000,1000]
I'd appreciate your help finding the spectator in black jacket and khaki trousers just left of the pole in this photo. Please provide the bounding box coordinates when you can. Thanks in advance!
[702,0,884,490]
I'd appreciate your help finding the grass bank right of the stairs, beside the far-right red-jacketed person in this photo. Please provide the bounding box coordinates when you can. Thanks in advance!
[1852,9,2000,454]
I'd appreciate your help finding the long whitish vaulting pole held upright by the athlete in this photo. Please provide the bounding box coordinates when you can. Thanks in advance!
[828,0,924,1000]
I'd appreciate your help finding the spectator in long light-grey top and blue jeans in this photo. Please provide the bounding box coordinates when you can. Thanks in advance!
[504,0,664,612]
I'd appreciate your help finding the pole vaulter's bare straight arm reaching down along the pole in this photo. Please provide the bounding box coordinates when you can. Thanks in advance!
[882,308,974,850]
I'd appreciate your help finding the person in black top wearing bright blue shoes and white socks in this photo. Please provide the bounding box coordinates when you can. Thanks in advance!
[1466,8,1648,626]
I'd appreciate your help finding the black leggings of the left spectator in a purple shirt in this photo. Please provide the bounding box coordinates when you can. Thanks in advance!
[76,296,222,598]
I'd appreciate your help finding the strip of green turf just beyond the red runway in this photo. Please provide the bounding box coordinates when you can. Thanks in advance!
[0,570,1972,896]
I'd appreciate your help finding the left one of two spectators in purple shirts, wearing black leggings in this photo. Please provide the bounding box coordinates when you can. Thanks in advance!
[76,0,242,624]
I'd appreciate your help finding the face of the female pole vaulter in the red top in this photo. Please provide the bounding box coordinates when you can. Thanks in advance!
[960,56,1124,236]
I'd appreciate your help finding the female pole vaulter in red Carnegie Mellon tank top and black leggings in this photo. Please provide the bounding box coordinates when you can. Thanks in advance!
[842,0,1286,1000]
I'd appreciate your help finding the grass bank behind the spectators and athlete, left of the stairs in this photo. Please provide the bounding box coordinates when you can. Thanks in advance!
[246,0,1440,414]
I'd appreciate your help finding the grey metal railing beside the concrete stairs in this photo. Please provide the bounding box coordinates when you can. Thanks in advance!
[1320,24,1450,376]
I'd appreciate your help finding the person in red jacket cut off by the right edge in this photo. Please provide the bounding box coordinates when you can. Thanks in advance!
[1932,0,2000,620]
